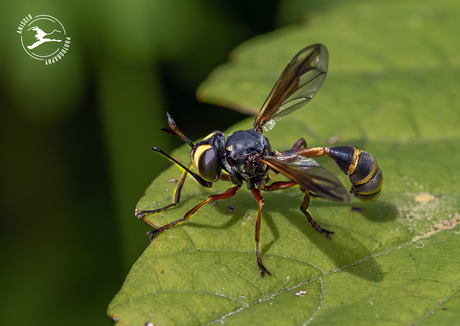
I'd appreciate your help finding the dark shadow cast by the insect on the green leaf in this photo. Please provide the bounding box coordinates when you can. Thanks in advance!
[165,190,384,282]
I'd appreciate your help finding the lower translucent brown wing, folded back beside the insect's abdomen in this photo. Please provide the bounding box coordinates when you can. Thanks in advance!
[261,155,350,203]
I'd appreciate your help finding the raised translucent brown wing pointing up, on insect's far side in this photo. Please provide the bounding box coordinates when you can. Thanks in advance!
[253,44,329,131]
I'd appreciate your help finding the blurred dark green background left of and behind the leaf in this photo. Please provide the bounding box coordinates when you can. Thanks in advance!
[0,0,320,325]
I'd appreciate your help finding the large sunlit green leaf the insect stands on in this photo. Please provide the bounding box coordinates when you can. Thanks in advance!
[109,1,460,326]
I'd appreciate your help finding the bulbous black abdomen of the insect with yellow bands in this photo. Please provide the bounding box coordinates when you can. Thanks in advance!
[325,146,383,203]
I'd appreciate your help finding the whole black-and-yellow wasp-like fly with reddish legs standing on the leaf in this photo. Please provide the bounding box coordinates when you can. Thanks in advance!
[135,44,383,277]
